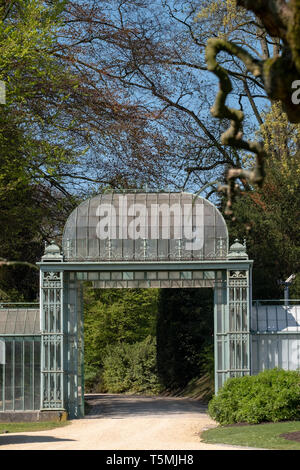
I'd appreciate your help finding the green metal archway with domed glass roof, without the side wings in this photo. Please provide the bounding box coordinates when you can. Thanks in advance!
[39,192,252,418]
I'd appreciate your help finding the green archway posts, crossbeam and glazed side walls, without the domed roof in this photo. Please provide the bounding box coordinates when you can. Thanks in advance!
[0,282,300,418]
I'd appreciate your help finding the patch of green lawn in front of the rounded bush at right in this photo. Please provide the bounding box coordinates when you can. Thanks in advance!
[201,421,300,450]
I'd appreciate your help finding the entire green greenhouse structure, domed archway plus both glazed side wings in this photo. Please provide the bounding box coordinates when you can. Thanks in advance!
[0,191,300,422]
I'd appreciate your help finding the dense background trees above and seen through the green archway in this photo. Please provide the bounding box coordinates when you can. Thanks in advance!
[0,0,300,392]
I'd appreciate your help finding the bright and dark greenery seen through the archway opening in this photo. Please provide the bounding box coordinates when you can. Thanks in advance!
[84,287,213,393]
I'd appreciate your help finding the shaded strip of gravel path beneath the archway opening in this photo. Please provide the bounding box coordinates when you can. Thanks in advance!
[85,394,207,419]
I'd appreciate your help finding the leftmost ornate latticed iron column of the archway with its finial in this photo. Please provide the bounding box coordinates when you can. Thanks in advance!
[40,242,64,410]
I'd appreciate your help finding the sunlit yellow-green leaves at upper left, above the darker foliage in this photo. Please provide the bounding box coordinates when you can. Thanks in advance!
[0,0,75,196]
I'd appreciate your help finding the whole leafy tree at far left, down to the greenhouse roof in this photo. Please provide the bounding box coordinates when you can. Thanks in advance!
[0,0,81,300]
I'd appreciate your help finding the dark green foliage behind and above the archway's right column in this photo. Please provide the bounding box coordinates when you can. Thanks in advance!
[227,104,300,299]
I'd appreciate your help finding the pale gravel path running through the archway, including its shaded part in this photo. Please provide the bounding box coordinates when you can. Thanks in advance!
[0,395,255,450]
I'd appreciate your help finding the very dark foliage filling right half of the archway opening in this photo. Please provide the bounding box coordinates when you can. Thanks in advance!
[157,289,213,389]
